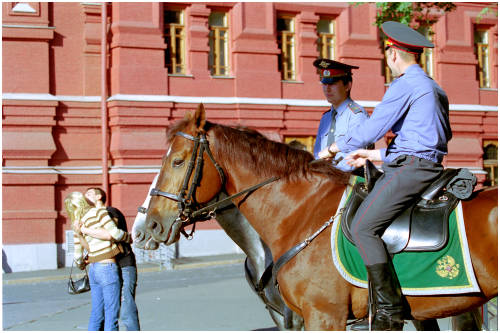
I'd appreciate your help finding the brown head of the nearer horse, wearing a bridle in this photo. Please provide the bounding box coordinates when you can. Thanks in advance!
[145,104,224,245]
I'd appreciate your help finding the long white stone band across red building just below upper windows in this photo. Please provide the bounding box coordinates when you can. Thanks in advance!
[2,93,498,112]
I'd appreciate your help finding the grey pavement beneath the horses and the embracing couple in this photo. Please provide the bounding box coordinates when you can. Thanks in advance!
[2,255,490,331]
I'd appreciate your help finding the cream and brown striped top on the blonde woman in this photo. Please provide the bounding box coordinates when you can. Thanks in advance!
[74,207,130,263]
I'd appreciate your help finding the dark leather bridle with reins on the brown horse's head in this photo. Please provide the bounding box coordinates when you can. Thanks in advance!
[150,132,279,238]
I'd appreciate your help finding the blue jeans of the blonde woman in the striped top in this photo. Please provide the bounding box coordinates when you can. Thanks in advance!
[88,263,120,331]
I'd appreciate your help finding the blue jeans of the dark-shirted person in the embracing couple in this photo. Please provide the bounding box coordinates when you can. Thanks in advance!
[120,266,141,331]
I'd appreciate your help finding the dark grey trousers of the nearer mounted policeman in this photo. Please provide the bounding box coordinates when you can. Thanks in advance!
[352,155,443,265]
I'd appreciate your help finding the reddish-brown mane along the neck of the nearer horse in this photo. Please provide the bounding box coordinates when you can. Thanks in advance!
[205,122,350,184]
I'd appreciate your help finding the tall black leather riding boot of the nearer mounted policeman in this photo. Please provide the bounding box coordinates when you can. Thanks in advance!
[351,263,404,331]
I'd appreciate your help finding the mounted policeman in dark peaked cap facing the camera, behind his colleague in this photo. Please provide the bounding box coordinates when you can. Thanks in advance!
[313,59,368,172]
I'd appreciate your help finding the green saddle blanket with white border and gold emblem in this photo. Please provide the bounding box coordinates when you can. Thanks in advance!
[331,176,480,295]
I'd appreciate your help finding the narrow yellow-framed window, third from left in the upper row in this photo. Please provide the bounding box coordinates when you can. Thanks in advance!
[277,16,296,81]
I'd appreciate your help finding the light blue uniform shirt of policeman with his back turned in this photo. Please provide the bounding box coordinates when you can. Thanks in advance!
[335,64,452,163]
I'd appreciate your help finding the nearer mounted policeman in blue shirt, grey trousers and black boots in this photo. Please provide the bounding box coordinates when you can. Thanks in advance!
[319,22,452,330]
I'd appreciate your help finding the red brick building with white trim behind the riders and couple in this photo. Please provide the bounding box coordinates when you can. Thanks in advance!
[2,2,498,271]
